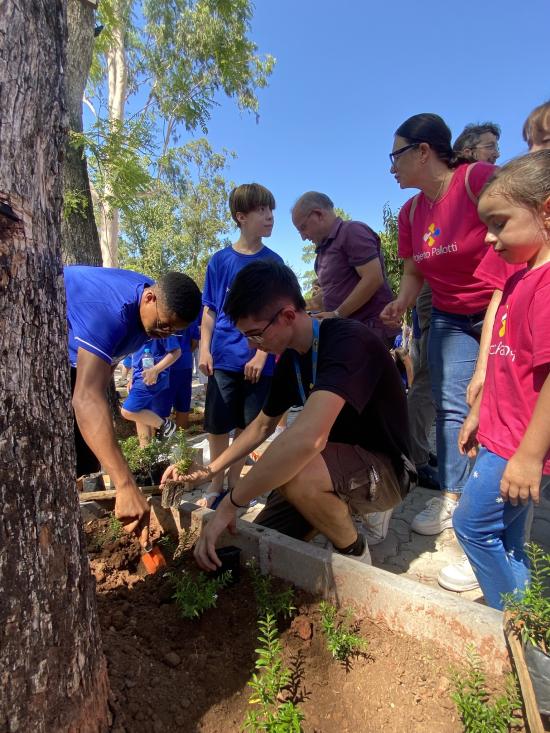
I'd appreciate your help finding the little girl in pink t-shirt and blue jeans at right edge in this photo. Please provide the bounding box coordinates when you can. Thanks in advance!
[453,150,550,608]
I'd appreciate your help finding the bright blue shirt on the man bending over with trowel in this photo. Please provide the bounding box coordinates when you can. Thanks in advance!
[63,265,154,366]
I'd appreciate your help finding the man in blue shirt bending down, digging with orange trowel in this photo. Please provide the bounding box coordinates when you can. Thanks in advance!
[64,265,201,544]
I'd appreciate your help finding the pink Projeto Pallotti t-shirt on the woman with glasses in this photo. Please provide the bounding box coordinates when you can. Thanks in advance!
[399,162,508,315]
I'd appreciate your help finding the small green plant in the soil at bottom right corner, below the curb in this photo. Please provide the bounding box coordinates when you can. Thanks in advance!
[451,645,521,733]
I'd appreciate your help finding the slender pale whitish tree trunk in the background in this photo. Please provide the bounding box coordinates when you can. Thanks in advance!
[99,0,129,267]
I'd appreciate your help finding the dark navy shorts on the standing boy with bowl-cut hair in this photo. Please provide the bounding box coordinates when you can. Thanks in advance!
[204,369,271,435]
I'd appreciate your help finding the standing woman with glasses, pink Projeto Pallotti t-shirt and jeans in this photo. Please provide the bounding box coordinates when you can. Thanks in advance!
[381,113,511,544]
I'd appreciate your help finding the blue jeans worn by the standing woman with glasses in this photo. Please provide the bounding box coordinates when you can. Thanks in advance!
[428,308,485,493]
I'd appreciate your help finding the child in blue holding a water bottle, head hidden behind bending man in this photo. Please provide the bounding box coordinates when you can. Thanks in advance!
[120,336,181,448]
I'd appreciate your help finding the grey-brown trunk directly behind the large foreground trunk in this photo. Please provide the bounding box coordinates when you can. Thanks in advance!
[61,0,101,265]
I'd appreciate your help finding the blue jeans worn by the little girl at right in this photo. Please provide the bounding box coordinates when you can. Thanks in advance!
[453,448,531,609]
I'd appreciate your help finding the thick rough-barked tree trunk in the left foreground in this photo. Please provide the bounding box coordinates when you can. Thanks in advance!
[0,0,109,733]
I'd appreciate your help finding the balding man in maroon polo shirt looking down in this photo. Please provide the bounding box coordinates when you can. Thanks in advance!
[292,191,398,347]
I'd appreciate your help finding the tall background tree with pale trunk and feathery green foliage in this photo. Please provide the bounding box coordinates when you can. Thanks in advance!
[83,0,274,268]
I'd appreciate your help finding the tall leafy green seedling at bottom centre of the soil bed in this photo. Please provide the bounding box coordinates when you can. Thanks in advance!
[243,612,304,733]
